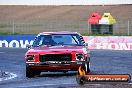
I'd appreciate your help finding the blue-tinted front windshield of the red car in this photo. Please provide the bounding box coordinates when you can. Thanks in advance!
[32,34,84,47]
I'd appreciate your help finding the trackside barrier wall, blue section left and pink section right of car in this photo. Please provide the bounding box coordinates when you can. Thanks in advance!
[0,35,132,50]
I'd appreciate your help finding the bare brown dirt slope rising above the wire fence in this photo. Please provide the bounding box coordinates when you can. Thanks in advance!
[0,5,132,21]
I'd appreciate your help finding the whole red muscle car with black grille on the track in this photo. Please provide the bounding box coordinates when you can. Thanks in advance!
[25,32,90,77]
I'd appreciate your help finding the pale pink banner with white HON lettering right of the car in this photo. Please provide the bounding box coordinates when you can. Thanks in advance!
[84,36,132,50]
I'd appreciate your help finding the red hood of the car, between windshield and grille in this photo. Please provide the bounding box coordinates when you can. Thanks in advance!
[27,46,86,53]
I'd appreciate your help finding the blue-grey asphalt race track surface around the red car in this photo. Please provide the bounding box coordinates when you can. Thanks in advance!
[0,48,132,88]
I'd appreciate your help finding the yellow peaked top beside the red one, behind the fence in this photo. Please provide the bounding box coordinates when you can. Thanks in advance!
[99,13,116,24]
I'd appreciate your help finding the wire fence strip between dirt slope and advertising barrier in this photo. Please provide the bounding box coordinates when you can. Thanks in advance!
[0,20,132,35]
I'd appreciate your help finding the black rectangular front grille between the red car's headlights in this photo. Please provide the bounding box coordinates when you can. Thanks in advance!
[39,54,72,62]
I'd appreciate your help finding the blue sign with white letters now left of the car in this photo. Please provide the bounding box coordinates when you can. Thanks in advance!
[0,35,35,48]
